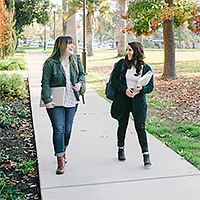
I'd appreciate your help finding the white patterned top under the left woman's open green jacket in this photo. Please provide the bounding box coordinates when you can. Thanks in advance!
[62,59,78,108]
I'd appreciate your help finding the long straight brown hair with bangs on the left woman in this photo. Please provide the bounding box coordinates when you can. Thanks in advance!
[50,36,74,60]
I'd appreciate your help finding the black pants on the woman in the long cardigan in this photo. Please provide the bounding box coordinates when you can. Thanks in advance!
[117,98,149,153]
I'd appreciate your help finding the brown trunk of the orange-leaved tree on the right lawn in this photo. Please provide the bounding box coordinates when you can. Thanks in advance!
[162,0,177,79]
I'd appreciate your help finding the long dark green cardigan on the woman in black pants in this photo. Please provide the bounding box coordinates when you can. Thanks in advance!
[111,59,154,123]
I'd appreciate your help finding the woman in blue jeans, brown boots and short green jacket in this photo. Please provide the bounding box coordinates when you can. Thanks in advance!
[41,36,85,174]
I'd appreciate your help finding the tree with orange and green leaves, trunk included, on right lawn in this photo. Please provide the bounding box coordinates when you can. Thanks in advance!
[123,0,200,79]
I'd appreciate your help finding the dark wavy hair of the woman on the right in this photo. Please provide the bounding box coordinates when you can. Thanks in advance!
[124,42,144,76]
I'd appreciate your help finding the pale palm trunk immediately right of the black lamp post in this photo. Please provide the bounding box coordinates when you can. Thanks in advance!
[86,12,94,56]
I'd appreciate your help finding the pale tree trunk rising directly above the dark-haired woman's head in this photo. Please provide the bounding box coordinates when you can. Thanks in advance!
[117,0,127,57]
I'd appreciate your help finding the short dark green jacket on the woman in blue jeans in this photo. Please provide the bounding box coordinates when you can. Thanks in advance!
[41,55,85,104]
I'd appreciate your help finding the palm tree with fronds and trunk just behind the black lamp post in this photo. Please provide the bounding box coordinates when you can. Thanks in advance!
[65,0,109,56]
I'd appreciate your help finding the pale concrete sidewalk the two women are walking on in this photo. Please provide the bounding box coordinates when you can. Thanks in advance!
[27,50,200,200]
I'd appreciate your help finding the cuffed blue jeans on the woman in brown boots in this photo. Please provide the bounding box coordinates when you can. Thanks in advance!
[47,104,78,156]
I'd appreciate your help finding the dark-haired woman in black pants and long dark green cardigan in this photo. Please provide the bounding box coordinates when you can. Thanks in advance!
[111,42,154,167]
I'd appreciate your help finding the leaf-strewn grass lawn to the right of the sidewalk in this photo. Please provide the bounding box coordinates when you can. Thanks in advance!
[87,49,200,169]
